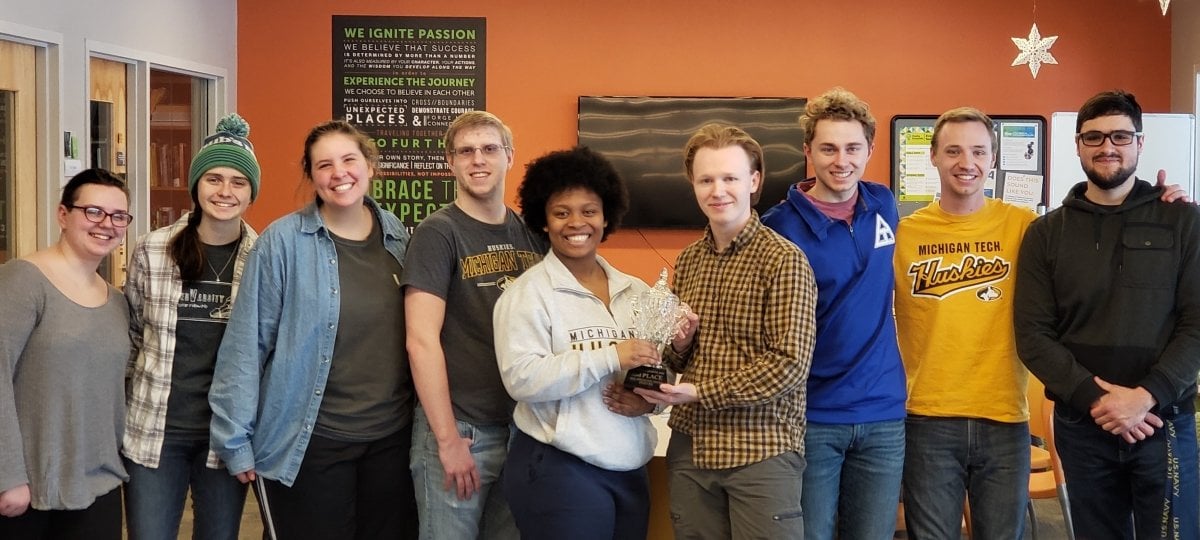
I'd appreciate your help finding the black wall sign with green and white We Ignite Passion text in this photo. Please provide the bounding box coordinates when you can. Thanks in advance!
[332,16,487,229]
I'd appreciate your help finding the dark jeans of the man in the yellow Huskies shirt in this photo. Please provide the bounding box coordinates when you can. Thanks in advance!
[904,415,1030,540]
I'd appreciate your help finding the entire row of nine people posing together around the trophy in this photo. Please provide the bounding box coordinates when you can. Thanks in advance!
[0,89,1200,540]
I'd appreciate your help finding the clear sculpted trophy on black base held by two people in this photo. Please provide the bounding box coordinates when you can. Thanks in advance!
[625,268,686,390]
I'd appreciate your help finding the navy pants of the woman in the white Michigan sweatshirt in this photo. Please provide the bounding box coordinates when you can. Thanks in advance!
[504,431,650,540]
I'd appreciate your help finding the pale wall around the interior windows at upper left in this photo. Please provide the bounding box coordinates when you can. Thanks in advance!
[0,0,238,246]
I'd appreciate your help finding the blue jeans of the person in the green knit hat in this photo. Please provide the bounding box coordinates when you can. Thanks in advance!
[125,437,246,540]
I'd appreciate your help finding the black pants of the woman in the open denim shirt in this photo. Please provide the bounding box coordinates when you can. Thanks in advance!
[264,425,418,540]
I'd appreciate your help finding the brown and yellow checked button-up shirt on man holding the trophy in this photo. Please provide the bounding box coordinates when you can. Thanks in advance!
[664,214,817,469]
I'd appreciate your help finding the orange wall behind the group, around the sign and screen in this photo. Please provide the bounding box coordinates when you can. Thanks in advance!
[238,0,1171,281]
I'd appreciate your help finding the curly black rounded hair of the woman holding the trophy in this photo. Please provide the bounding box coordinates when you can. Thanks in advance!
[517,146,629,241]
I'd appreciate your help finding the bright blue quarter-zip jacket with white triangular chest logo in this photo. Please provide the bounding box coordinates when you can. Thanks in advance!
[762,179,906,424]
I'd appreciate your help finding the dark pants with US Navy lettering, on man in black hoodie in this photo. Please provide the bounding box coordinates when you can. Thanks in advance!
[1054,404,1200,540]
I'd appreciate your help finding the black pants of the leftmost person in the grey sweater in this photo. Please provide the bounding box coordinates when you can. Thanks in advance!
[0,487,121,540]
